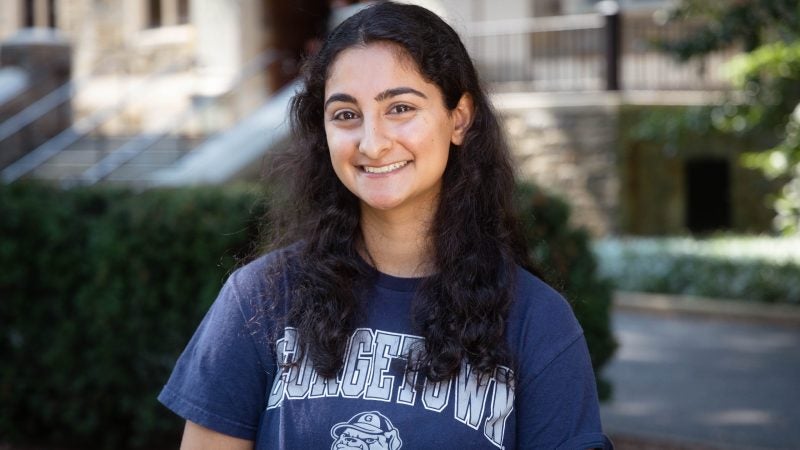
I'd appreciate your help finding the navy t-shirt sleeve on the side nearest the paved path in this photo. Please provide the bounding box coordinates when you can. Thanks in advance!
[515,268,613,450]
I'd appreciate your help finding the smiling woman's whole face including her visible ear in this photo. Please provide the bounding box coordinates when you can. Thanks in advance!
[324,43,472,216]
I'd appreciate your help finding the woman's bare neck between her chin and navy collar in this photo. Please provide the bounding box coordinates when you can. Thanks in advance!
[361,203,435,278]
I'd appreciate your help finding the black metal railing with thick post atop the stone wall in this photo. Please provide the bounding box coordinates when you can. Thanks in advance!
[465,9,736,91]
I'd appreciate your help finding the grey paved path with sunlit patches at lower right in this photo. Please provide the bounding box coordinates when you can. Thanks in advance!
[601,311,800,449]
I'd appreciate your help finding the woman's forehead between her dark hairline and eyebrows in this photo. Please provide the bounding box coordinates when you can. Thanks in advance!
[325,42,438,96]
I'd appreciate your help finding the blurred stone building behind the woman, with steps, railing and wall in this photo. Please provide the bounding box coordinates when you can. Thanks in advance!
[0,0,771,235]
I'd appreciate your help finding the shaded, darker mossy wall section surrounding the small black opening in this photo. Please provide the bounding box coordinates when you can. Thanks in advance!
[618,105,780,235]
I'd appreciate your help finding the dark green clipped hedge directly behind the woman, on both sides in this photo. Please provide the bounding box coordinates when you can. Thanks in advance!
[0,183,614,449]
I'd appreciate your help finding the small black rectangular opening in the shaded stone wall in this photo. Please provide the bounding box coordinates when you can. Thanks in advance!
[686,158,731,233]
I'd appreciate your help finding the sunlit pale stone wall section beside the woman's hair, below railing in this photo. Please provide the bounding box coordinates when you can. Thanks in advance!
[494,93,619,236]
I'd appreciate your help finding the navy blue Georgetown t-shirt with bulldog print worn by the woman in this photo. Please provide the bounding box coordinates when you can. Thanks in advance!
[158,251,612,450]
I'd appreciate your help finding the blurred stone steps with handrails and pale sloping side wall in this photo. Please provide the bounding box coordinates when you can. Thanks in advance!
[2,73,299,187]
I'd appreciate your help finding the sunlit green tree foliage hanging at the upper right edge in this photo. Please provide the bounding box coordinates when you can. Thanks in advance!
[660,0,800,234]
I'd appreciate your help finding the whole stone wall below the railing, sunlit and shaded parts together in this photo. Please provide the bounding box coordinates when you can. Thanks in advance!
[493,92,779,236]
